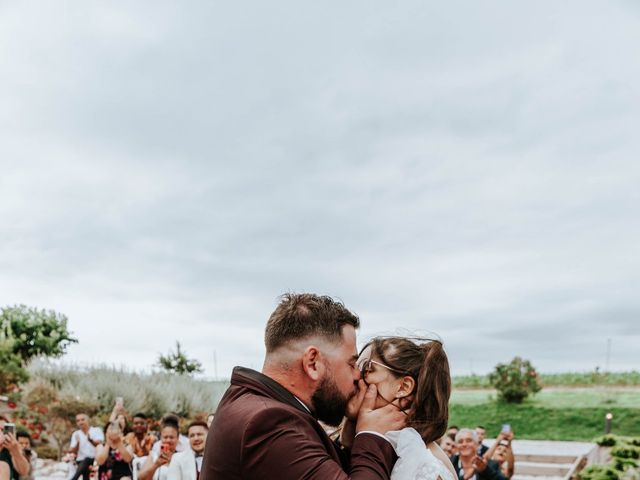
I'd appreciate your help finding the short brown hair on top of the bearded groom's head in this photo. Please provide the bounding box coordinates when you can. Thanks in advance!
[264,293,360,353]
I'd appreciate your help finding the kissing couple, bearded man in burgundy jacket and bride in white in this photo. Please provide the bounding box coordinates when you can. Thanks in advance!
[200,293,455,480]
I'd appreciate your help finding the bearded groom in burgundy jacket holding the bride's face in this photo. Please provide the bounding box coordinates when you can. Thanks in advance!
[200,294,406,480]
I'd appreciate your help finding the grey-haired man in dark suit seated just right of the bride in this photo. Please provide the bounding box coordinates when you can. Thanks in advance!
[451,428,506,480]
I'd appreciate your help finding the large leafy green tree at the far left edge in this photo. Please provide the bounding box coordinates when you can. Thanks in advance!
[0,305,78,392]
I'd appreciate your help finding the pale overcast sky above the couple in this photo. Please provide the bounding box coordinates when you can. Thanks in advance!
[0,0,640,378]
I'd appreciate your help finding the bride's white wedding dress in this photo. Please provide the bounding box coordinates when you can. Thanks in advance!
[385,428,454,480]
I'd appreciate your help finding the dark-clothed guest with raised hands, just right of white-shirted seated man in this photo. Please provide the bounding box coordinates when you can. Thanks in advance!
[96,420,133,480]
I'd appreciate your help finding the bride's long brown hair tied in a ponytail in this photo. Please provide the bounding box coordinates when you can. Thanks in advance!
[365,337,451,444]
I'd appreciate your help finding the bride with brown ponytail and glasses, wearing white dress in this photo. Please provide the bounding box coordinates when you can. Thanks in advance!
[341,337,456,480]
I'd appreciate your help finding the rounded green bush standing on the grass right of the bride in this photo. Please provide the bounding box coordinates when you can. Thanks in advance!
[489,357,542,403]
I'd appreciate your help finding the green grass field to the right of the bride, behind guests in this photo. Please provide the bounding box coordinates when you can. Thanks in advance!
[449,387,640,441]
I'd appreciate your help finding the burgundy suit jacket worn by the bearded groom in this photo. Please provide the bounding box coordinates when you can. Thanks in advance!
[200,367,397,480]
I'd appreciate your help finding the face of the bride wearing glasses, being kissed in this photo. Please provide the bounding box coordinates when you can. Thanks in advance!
[358,346,410,408]
